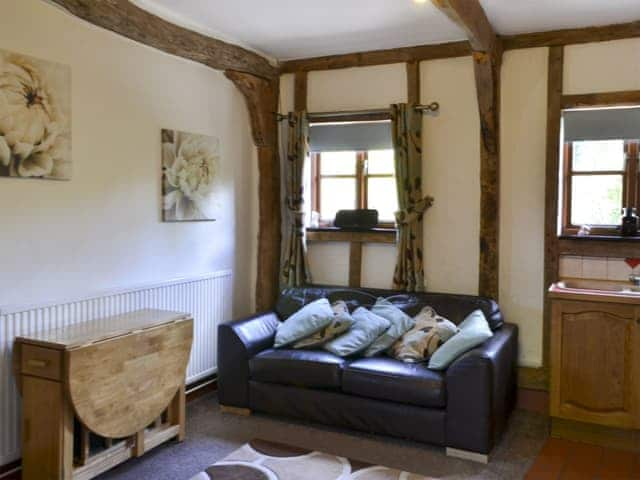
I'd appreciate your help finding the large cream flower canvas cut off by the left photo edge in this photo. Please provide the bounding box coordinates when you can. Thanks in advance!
[0,49,71,180]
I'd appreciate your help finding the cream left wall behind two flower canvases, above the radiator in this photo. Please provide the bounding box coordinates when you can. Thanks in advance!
[0,0,257,315]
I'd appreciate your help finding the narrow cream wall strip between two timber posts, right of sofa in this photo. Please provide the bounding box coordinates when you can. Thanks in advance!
[500,48,548,366]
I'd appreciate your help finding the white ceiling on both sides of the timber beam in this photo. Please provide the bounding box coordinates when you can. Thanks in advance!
[130,0,640,60]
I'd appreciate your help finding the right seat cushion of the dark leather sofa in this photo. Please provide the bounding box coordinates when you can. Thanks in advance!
[342,357,446,408]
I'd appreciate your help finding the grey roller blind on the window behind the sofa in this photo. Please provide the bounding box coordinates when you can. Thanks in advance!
[309,121,393,152]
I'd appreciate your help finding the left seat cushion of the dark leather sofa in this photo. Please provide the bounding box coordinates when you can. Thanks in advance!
[249,349,345,388]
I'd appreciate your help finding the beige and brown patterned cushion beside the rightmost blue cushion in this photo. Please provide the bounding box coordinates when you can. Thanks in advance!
[389,307,459,363]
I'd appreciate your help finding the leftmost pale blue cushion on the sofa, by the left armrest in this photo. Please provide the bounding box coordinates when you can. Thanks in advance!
[273,298,333,348]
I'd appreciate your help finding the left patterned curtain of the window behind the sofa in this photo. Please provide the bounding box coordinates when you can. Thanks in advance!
[282,112,311,287]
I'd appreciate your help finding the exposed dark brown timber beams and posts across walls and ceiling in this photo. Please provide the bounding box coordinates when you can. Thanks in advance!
[50,0,640,382]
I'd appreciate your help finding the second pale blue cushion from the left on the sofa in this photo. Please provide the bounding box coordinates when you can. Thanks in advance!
[322,307,391,357]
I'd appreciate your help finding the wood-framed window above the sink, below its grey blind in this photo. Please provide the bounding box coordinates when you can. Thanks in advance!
[562,140,640,235]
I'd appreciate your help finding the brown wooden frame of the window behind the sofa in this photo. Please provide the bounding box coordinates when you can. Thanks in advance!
[311,150,396,228]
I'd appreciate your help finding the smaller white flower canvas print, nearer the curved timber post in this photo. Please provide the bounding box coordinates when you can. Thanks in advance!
[162,130,220,222]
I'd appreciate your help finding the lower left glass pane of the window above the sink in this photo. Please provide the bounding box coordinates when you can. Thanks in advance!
[571,175,622,225]
